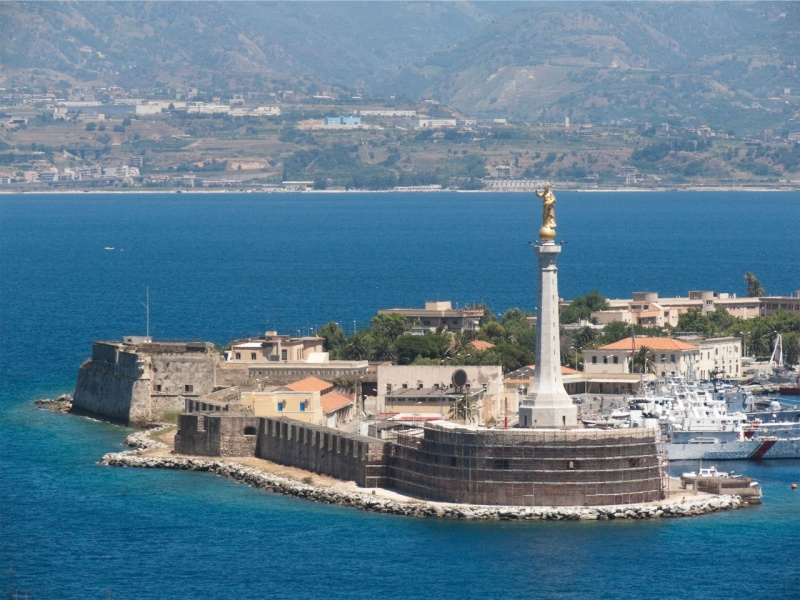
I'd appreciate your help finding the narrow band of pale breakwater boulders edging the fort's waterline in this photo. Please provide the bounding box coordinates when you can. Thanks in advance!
[101,451,746,521]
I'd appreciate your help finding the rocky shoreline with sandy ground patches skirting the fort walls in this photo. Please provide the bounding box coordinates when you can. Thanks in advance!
[100,428,748,521]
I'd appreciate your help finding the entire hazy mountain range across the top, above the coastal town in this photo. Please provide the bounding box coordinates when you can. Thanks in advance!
[0,1,800,129]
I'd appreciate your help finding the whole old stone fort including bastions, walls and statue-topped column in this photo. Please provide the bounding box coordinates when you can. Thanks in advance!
[74,188,667,506]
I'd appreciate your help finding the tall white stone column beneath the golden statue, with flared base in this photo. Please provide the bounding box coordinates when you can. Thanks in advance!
[519,242,578,428]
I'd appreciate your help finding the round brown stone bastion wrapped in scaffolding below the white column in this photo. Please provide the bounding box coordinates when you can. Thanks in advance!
[387,425,666,506]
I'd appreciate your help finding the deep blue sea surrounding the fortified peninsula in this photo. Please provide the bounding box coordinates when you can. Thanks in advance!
[0,192,800,600]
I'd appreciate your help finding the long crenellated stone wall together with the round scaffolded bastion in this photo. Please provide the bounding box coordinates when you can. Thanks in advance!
[175,410,666,506]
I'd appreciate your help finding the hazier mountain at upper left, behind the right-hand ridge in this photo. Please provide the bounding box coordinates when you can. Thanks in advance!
[0,2,508,90]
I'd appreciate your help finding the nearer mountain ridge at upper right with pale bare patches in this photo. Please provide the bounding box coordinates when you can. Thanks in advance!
[386,2,800,127]
